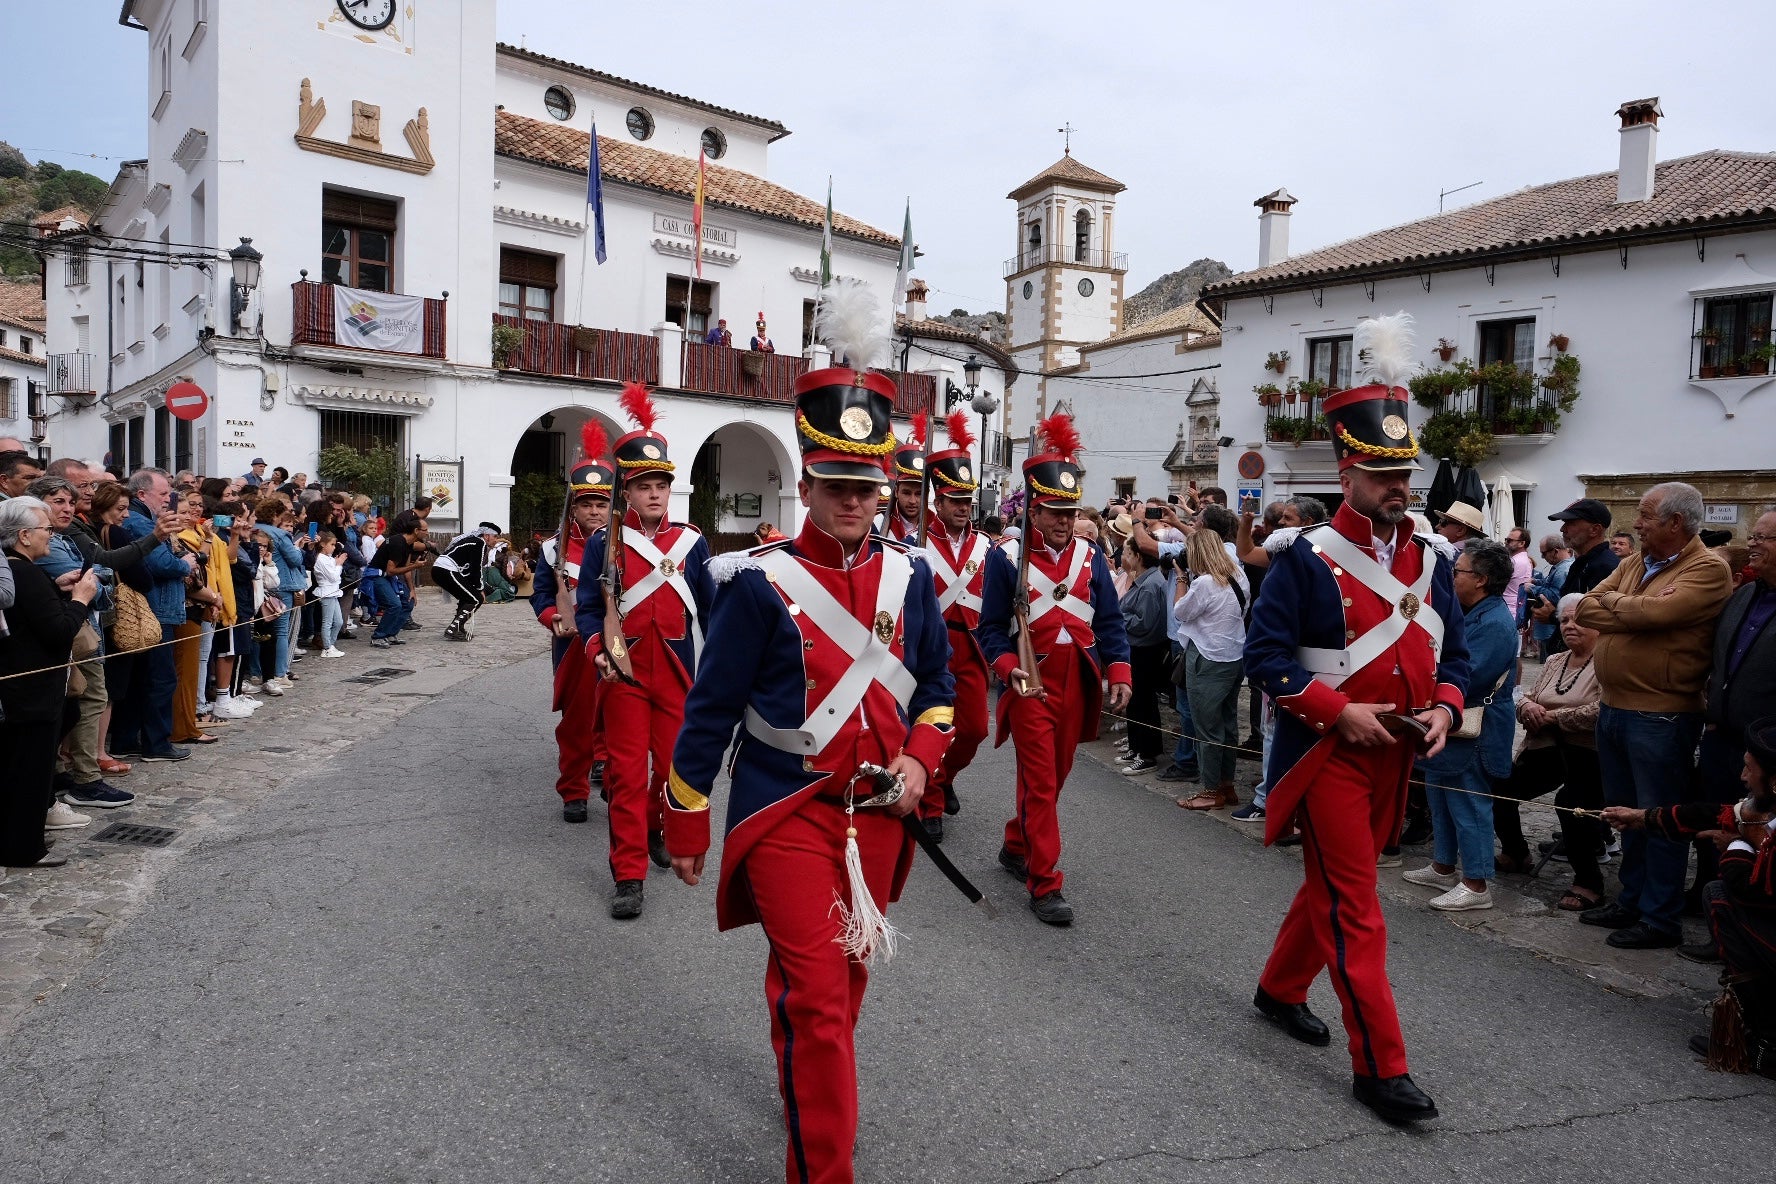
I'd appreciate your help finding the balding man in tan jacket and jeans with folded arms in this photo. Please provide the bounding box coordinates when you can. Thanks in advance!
[1579,481,1732,950]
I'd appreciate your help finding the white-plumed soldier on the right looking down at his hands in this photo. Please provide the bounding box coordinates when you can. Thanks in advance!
[1245,314,1469,1122]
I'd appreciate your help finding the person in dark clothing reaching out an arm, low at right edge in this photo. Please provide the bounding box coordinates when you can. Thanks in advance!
[1604,719,1776,1077]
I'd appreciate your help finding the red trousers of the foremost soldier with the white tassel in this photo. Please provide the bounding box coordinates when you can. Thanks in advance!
[744,797,908,1184]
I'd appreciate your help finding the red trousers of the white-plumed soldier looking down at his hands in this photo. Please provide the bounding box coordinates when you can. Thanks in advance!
[1257,740,1412,1077]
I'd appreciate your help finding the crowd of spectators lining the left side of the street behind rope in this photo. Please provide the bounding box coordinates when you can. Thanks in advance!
[0,449,527,884]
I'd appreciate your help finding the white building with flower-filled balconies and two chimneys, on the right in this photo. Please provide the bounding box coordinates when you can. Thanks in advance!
[1202,99,1776,540]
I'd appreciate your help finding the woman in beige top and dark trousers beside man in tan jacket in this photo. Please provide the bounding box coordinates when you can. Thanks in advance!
[1492,593,1604,912]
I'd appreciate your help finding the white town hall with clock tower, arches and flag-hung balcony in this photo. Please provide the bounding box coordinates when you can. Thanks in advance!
[43,0,1008,536]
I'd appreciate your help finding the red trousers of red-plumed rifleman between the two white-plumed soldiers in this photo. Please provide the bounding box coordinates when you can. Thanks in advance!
[1001,643,1085,896]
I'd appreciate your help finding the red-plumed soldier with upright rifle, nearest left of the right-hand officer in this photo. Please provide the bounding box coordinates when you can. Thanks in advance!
[975,415,1130,925]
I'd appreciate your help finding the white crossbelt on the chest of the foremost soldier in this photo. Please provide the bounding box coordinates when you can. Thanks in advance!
[746,547,918,756]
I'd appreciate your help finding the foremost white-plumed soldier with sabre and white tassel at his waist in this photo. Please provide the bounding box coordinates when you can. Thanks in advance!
[666,331,952,1184]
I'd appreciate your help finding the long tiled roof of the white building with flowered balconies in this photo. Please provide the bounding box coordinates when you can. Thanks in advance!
[1202,149,1776,300]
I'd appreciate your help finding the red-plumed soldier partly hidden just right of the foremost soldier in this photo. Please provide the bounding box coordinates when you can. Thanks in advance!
[902,412,993,840]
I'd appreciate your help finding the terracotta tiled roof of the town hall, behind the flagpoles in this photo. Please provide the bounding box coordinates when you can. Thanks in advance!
[494,112,900,247]
